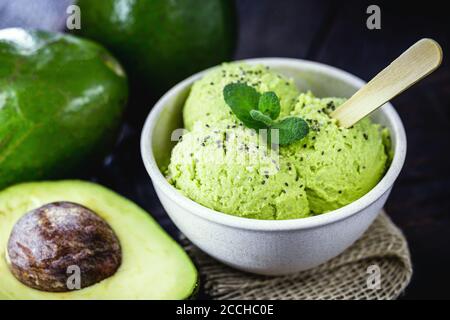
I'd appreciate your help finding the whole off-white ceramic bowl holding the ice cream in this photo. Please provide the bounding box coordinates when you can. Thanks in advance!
[141,58,406,275]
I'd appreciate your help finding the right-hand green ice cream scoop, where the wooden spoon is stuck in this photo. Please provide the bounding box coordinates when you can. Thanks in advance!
[280,93,389,214]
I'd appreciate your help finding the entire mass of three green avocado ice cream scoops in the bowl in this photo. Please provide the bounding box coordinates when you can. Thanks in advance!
[167,64,389,219]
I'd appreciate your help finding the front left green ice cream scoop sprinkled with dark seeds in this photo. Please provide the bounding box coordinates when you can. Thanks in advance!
[168,123,310,219]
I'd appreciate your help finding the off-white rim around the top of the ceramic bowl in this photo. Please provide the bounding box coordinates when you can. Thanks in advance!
[141,58,406,231]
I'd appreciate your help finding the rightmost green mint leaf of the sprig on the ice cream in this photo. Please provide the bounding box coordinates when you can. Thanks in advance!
[269,117,309,146]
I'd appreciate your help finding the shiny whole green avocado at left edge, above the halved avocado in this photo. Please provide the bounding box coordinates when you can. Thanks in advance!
[0,28,128,189]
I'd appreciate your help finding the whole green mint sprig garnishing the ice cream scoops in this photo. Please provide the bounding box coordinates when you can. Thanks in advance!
[223,82,309,145]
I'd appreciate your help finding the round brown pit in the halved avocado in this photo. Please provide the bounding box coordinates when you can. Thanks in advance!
[6,202,122,292]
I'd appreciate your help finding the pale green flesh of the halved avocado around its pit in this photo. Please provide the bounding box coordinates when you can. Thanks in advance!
[0,181,197,300]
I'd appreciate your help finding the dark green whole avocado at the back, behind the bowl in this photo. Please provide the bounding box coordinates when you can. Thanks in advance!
[77,0,235,96]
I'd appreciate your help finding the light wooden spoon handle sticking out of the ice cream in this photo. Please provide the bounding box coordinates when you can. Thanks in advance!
[331,39,442,128]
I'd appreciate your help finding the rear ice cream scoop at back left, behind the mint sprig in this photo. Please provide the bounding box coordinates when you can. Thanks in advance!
[183,63,299,130]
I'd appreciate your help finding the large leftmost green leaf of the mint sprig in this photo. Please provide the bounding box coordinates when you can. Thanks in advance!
[223,82,266,129]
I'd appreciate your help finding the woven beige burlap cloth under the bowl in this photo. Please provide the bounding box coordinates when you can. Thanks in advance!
[183,213,412,300]
